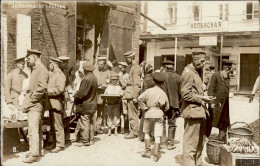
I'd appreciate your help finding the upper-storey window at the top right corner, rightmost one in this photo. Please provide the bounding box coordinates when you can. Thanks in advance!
[246,1,259,20]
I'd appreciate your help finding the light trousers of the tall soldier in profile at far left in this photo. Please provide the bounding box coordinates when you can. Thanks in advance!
[28,110,43,157]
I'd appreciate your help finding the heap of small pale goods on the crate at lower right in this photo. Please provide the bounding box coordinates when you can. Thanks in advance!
[228,138,257,153]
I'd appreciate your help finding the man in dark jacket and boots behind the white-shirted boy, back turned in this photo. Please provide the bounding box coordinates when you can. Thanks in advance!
[161,60,181,150]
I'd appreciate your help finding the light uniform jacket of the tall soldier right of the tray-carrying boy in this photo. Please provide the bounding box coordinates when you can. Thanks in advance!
[123,64,141,99]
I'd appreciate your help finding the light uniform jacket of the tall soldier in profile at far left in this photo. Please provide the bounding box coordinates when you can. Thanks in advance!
[21,63,49,112]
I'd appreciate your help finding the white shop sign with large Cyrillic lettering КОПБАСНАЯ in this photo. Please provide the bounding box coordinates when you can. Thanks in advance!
[190,21,223,33]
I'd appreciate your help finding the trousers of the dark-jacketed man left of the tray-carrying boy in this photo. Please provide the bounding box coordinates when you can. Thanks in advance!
[76,114,95,143]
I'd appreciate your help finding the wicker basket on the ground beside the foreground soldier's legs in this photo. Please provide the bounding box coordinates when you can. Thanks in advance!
[206,139,224,164]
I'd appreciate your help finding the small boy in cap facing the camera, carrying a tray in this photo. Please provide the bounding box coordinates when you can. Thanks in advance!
[104,73,123,136]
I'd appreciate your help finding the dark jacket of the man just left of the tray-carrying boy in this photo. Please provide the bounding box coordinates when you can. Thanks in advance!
[74,72,98,114]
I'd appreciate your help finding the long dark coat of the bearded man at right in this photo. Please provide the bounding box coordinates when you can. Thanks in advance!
[208,72,230,129]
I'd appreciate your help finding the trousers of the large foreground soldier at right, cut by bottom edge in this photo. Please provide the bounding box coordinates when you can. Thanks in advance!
[183,118,206,166]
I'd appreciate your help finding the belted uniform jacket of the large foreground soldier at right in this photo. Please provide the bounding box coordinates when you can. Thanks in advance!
[181,65,206,119]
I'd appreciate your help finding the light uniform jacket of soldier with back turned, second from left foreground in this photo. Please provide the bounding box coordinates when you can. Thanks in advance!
[47,69,66,111]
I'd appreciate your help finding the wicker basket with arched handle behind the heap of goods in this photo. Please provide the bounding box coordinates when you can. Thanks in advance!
[227,122,253,141]
